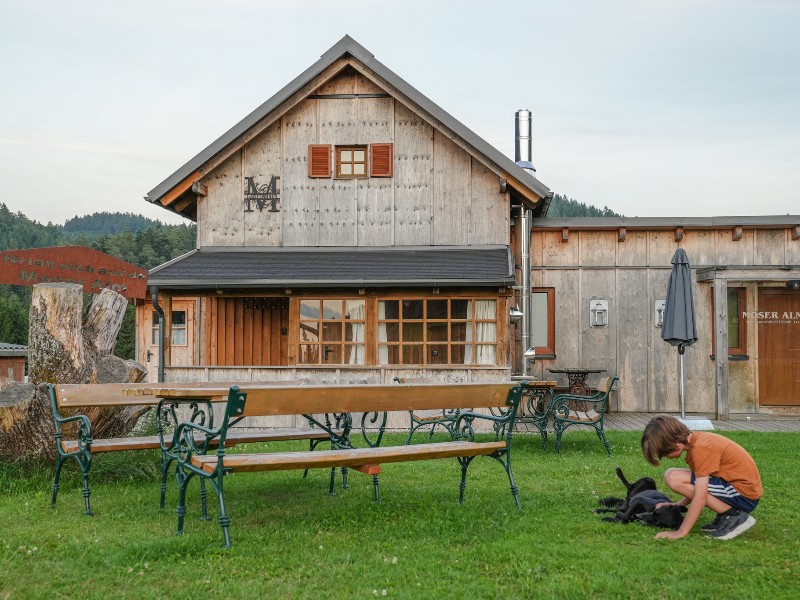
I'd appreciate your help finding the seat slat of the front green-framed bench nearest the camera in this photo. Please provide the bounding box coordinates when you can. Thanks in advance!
[192,441,506,473]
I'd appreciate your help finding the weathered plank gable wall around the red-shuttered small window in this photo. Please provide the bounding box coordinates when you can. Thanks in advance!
[197,69,511,247]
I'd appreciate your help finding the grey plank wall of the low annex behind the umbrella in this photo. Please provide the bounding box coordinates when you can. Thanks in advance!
[531,228,800,413]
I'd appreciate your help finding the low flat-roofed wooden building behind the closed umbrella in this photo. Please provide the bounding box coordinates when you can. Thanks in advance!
[531,215,800,418]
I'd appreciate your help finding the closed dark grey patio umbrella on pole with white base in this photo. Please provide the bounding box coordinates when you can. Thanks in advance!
[661,248,713,429]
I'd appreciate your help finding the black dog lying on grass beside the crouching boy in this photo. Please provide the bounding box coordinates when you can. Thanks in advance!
[594,467,686,529]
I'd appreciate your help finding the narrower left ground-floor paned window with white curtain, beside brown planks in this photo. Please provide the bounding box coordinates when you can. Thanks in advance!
[298,298,366,365]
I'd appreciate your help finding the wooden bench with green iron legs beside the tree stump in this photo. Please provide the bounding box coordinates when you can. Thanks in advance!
[48,383,334,516]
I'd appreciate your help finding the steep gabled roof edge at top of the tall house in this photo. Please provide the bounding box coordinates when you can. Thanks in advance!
[145,35,550,218]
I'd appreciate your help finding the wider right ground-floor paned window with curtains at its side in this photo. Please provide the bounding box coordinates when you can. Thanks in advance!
[378,298,497,365]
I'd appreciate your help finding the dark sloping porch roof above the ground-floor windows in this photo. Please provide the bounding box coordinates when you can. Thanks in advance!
[148,246,515,289]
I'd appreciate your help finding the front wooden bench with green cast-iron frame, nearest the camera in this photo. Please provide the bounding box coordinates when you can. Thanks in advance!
[159,383,526,547]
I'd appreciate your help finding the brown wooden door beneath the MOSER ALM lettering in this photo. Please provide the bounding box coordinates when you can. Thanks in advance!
[755,288,800,406]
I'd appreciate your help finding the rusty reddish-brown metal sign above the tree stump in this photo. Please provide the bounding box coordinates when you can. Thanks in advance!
[0,246,148,299]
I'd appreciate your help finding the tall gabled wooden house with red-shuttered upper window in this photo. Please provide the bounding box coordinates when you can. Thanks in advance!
[137,36,552,383]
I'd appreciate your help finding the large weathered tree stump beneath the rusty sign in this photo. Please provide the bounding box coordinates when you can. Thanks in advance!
[0,283,148,460]
